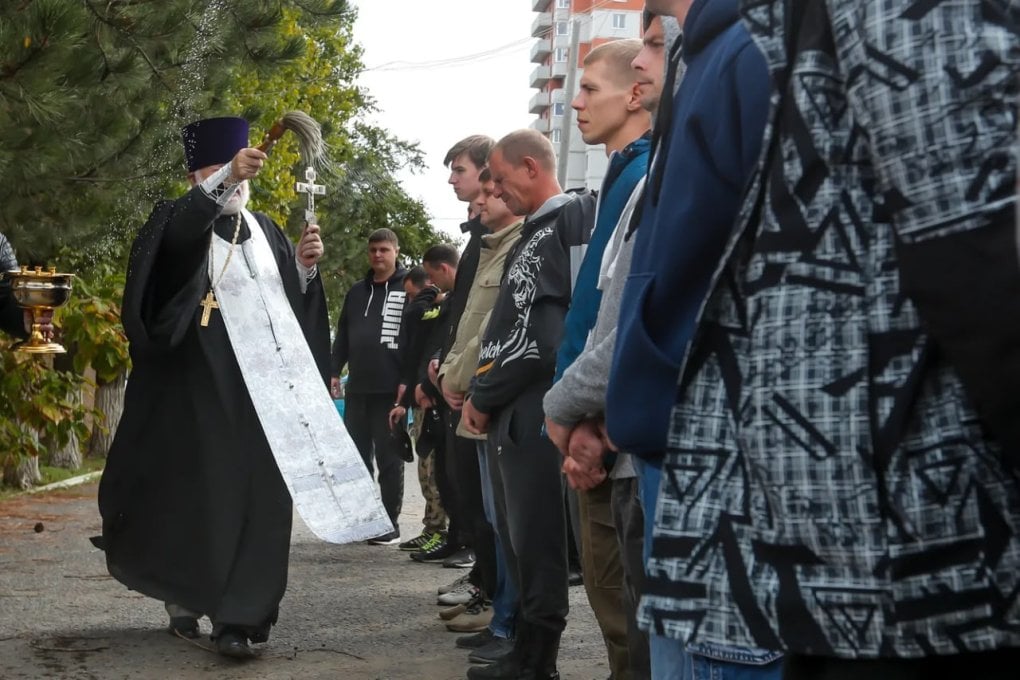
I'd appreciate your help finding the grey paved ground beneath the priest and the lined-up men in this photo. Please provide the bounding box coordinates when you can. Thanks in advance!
[0,465,609,680]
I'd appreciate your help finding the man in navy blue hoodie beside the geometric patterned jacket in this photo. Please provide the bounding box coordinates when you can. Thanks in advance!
[606,0,780,679]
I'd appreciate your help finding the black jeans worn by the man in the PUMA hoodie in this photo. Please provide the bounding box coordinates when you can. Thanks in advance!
[344,394,404,532]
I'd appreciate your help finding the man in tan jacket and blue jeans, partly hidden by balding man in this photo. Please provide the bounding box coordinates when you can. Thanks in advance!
[440,169,524,663]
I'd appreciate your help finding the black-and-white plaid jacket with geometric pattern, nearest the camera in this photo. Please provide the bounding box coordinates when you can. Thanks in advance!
[640,0,1020,658]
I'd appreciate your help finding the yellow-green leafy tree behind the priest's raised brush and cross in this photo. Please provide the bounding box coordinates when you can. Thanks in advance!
[226,8,443,318]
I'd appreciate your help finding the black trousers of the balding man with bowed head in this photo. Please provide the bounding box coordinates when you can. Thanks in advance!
[489,389,569,634]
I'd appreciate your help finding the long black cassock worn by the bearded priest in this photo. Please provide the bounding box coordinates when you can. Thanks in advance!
[99,188,329,641]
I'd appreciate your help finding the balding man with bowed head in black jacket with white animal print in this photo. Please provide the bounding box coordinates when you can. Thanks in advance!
[461,129,595,680]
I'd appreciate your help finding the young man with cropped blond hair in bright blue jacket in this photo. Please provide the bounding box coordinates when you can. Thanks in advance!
[546,40,652,678]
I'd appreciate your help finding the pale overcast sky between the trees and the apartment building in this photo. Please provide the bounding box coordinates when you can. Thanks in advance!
[354,0,536,241]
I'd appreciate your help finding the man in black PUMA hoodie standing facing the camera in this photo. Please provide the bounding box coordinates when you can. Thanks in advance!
[332,228,407,545]
